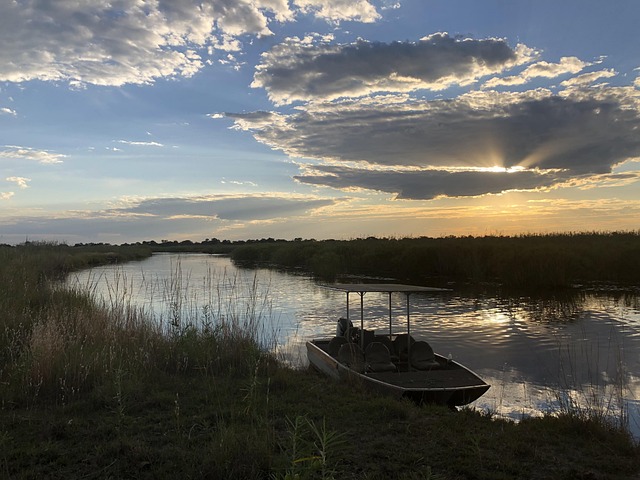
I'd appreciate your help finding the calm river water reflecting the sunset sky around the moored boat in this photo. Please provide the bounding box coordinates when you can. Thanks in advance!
[69,254,640,437]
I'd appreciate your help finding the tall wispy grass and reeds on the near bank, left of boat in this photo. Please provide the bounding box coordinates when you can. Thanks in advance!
[0,244,267,405]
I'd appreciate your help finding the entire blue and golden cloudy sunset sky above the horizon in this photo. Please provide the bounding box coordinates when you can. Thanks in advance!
[0,0,640,244]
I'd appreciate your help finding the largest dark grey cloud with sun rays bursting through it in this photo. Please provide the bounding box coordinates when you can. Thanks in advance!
[225,87,640,199]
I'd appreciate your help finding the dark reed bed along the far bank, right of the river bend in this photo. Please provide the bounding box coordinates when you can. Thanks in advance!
[231,232,640,289]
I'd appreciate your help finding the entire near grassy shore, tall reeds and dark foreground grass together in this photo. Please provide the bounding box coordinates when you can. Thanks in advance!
[0,244,640,479]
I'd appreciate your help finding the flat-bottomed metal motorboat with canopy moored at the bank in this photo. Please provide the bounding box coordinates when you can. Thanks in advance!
[306,283,490,408]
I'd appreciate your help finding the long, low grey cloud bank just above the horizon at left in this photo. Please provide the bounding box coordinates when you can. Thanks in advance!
[0,193,338,243]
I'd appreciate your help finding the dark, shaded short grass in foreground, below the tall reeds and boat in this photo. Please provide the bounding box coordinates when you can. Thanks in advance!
[5,366,640,479]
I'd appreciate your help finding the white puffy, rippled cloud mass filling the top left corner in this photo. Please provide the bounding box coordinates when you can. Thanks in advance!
[0,0,376,87]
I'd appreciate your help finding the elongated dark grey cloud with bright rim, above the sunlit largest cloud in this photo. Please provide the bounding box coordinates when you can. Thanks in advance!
[251,33,534,105]
